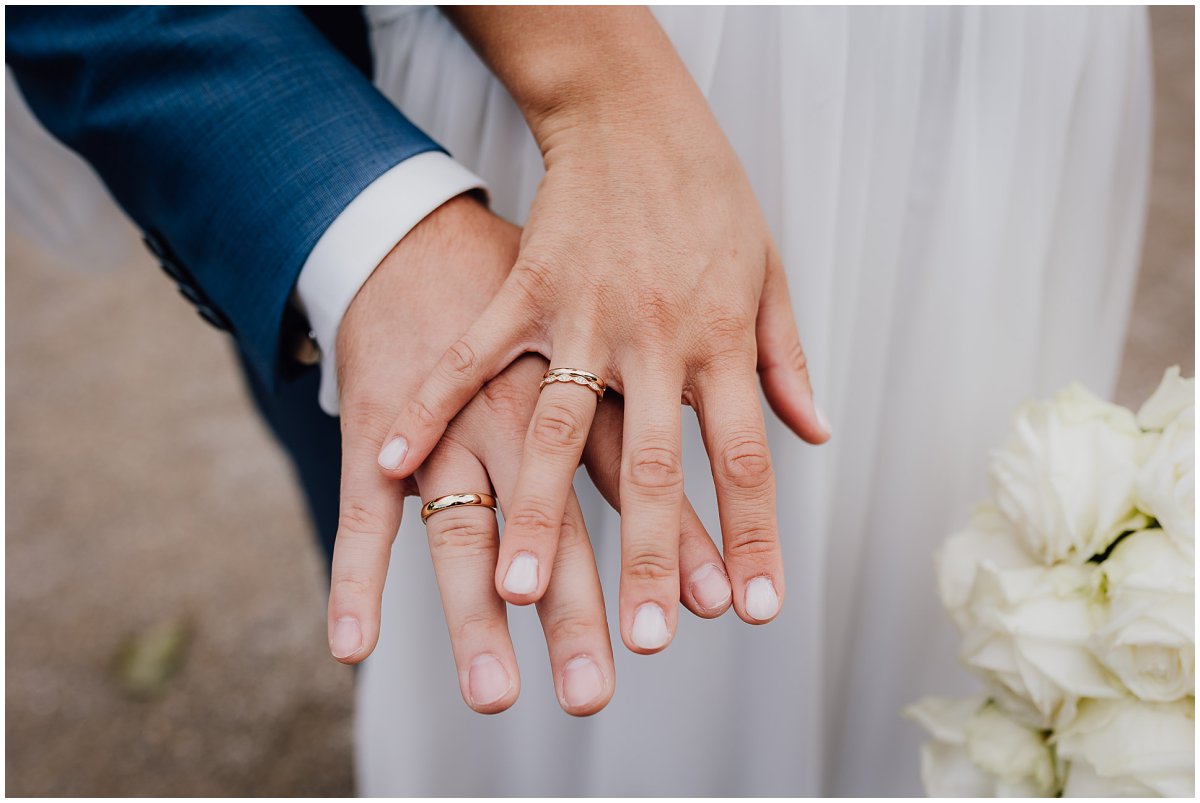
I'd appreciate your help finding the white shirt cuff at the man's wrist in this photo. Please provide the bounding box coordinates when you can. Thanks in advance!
[296,151,487,415]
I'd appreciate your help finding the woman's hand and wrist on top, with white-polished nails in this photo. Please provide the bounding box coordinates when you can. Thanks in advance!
[380,8,829,652]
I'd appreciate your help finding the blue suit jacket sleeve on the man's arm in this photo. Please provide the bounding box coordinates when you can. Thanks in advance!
[5,6,439,386]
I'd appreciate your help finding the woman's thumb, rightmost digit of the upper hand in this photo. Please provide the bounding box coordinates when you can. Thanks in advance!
[755,248,833,444]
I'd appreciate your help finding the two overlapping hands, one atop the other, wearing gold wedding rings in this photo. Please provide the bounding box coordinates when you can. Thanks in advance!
[329,8,829,715]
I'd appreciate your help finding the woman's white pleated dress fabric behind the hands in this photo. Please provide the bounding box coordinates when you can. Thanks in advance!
[356,7,1151,796]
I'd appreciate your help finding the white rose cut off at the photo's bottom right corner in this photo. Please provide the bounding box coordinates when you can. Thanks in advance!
[1054,697,1195,797]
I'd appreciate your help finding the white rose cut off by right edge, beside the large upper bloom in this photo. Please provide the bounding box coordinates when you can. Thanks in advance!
[1136,407,1196,558]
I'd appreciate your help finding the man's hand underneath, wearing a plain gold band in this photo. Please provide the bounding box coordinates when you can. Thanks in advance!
[329,196,728,715]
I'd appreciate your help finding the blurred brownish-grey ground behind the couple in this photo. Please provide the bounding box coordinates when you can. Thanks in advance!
[5,7,1195,796]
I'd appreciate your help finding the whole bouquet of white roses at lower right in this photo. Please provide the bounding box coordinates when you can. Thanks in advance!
[906,367,1195,797]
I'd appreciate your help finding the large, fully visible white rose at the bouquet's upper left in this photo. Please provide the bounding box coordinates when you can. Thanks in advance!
[990,384,1141,564]
